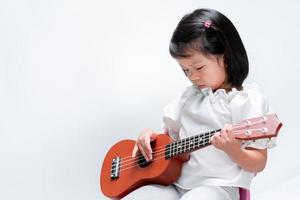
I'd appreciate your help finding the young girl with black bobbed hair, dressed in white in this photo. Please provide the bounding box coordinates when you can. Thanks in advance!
[124,9,274,200]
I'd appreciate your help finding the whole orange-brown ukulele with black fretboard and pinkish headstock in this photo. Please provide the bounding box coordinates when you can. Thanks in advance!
[100,113,282,199]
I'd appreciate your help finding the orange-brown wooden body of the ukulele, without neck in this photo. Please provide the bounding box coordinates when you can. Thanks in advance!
[100,134,186,199]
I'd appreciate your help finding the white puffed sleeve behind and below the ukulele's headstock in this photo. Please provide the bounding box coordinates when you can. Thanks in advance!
[230,86,276,149]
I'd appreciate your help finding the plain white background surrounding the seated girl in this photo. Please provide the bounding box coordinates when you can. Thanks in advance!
[0,0,300,200]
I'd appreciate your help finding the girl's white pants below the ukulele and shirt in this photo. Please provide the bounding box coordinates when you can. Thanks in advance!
[123,184,240,200]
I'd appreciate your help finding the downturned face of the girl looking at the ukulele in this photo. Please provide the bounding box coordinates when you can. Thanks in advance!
[176,52,228,90]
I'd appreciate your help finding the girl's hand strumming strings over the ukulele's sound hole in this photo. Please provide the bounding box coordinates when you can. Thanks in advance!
[132,129,157,161]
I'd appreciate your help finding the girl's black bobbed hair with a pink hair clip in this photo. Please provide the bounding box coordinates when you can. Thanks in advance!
[169,9,249,87]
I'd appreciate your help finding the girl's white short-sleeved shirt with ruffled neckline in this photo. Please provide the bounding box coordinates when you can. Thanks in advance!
[163,84,275,189]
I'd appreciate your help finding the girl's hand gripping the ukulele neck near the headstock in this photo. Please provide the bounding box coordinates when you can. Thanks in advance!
[210,124,242,155]
